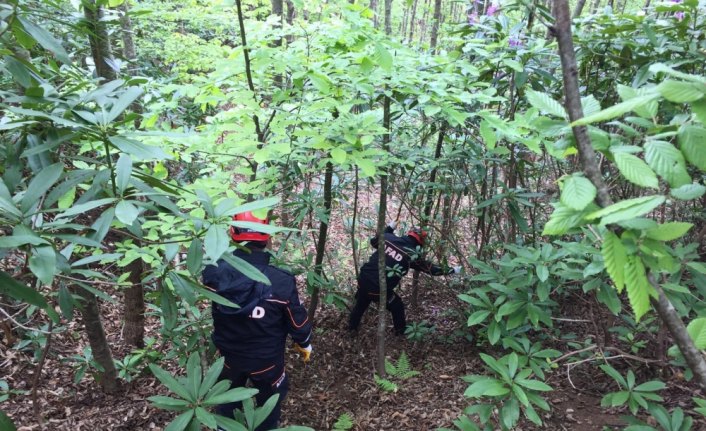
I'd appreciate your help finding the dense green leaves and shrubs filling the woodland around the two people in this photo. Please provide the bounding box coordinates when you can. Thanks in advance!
[0,0,706,430]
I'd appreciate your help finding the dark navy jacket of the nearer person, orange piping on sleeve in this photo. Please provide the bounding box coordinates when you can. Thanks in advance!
[203,250,311,359]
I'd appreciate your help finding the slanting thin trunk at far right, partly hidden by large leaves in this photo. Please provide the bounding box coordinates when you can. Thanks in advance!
[554,0,706,389]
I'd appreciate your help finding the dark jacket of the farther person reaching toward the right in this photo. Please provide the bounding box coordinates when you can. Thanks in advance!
[359,226,453,290]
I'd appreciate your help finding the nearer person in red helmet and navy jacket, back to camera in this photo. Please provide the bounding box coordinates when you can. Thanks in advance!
[198,212,312,431]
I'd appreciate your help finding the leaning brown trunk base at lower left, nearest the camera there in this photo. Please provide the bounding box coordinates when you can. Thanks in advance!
[74,287,118,394]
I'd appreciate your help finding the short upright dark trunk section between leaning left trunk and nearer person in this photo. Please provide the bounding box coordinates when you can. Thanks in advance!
[123,259,145,347]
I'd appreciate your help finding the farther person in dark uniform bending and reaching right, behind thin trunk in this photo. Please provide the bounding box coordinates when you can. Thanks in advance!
[348,223,461,335]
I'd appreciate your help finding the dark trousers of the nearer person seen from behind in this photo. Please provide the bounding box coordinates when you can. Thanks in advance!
[216,355,289,431]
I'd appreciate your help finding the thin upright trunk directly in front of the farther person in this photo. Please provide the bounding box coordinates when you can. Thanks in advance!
[377,96,390,377]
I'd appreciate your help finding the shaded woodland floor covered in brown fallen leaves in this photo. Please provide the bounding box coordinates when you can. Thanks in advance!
[0,194,706,431]
